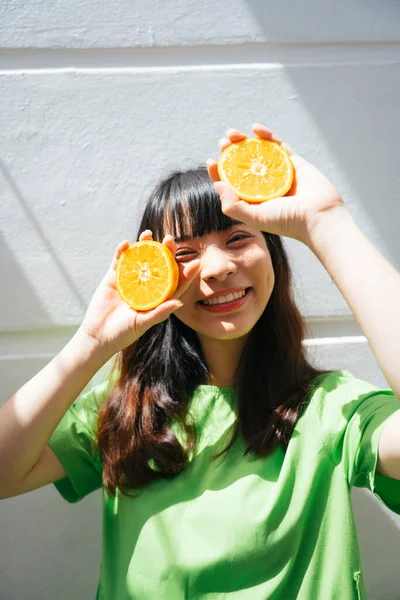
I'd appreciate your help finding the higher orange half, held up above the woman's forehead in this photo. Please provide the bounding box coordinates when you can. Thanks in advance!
[218,138,294,203]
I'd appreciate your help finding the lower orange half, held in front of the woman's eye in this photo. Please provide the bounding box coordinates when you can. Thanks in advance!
[116,240,179,311]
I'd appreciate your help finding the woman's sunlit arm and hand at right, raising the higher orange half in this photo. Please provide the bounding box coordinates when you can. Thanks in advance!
[207,124,400,479]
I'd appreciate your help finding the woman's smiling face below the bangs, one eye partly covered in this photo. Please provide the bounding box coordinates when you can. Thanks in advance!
[174,223,275,340]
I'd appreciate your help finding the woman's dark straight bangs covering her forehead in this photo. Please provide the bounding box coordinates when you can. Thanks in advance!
[137,167,240,242]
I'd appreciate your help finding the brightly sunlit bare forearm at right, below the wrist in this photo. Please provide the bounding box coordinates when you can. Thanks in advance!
[308,208,400,398]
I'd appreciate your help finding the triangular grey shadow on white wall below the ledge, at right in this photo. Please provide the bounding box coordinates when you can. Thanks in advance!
[285,65,400,268]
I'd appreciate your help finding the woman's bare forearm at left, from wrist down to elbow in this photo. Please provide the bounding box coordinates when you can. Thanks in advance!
[0,331,108,482]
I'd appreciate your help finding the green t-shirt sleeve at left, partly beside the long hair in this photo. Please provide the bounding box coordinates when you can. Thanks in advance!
[48,381,110,503]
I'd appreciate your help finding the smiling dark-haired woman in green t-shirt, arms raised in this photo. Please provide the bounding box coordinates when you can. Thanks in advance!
[0,125,400,600]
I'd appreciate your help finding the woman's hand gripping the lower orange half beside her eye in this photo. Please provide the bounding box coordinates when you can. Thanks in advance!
[79,229,199,358]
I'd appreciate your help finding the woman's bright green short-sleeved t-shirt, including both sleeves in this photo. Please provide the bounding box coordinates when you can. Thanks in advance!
[49,371,400,600]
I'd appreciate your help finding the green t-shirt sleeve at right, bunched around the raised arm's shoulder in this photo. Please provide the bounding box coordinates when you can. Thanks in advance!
[319,371,400,514]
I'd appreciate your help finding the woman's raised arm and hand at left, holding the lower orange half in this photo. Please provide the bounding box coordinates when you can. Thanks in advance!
[0,237,198,498]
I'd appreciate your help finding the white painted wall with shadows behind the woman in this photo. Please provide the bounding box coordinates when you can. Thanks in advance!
[0,0,400,600]
